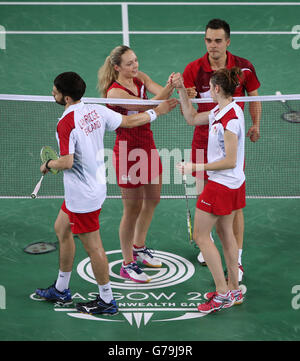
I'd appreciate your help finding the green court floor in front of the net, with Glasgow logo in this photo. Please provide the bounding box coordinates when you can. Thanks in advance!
[0,199,300,341]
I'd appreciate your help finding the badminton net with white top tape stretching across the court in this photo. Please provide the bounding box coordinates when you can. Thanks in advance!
[0,94,300,198]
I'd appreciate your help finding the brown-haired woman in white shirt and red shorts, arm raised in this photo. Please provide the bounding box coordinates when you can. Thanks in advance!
[172,68,246,313]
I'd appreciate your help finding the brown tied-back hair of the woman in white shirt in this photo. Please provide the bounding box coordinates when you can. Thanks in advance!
[210,67,243,97]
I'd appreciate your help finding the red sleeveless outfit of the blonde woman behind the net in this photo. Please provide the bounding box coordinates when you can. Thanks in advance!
[107,78,162,188]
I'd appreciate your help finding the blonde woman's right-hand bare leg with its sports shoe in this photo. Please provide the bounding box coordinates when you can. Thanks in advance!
[133,175,162,267]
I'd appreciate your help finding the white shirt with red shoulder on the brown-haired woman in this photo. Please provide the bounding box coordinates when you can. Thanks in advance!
[207,101,245,189]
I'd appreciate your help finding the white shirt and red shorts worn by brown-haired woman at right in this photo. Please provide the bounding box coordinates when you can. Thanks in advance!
[197,101,246,215]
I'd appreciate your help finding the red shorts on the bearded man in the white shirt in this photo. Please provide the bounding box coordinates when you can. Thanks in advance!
[61,201,101,234]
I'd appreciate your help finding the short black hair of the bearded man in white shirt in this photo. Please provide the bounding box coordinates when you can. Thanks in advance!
[54,71,86,100]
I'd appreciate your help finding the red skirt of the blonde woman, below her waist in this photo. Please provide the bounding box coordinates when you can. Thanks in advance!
[113,144,162,188]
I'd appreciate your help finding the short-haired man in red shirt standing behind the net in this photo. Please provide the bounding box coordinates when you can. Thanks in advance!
[183,19,261,281]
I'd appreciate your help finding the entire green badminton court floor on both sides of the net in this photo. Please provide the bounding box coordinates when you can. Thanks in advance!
[0,2,300,344]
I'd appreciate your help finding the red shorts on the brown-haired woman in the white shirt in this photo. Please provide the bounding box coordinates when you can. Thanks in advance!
[197,180,246,216]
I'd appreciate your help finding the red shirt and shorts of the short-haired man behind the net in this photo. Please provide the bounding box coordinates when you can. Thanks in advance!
[183,51,260,179]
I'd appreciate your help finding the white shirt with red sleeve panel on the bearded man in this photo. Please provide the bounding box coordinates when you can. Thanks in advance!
[56,102,122,213]
